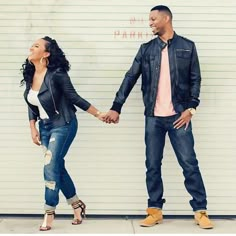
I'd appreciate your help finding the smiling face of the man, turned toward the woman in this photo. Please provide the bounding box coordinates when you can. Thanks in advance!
[149,10,167,36]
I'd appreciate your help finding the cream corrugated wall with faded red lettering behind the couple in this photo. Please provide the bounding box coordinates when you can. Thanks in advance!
[0,0,236,215]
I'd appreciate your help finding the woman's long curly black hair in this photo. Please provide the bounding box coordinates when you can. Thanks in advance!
[20,36,70,85]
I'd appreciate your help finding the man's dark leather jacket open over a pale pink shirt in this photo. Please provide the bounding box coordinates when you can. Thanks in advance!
[111,33,201,116]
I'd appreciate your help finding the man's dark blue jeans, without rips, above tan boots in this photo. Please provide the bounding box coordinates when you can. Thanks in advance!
[145,114,207,211]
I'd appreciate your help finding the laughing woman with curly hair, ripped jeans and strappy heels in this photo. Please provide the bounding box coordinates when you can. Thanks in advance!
[21,36,104,231]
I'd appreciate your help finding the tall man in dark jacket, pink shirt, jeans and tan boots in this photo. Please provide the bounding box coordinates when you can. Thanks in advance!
[104,5,213,229]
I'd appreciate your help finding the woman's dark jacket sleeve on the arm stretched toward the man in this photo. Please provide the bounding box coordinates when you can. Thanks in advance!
[55,72,91,111]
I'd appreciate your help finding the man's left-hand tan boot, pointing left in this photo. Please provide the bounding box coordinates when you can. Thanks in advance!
[139,208,163,227]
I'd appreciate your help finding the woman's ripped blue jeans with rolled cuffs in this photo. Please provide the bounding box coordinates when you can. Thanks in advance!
[39,118,78,210]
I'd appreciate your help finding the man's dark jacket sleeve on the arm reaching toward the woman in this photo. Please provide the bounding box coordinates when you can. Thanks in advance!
[111,45,142,113]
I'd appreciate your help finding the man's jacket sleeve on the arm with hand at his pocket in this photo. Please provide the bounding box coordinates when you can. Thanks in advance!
[188,44,201,108]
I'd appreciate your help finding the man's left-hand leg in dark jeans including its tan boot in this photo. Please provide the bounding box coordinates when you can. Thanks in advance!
[140,117,166,226]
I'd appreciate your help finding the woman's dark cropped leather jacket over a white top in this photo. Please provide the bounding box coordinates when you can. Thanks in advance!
[24,69,90,126]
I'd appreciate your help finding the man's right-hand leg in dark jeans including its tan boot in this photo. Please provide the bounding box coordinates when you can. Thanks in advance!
[168,118,213,228]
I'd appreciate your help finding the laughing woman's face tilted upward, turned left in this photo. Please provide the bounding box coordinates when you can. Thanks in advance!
[28,39,49,63]
